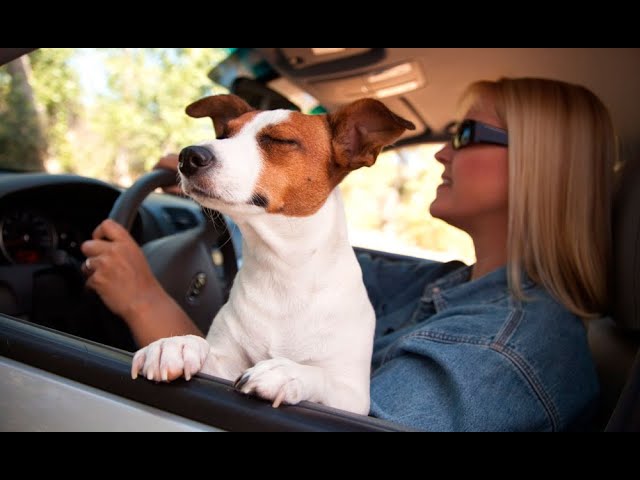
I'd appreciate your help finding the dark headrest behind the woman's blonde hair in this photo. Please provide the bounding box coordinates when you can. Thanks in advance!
[612,161,640,330]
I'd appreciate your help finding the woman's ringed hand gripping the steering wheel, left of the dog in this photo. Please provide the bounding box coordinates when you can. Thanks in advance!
[81,220,165,323]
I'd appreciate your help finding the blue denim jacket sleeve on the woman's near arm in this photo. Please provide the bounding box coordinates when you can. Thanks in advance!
[371,332,554,431]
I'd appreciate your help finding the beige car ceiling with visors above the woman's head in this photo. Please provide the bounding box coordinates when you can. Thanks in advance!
[259,48,640,159]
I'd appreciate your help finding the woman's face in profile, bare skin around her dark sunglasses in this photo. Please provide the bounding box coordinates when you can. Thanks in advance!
[429,98,509,234]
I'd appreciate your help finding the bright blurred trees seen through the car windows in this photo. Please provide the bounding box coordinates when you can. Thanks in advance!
[0,48,475,263]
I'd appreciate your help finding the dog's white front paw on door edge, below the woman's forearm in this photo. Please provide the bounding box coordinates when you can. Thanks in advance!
[131,335,210,382]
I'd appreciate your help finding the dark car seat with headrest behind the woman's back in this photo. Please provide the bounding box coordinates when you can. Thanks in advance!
[588,161,640,431]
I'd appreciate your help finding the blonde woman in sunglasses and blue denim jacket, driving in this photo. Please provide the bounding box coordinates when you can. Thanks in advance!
[83,78,616,430]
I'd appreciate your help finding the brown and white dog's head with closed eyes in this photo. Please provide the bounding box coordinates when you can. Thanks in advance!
[179,95,415,216]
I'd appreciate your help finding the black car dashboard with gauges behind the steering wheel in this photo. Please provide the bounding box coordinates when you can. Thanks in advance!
[0,173,205,348]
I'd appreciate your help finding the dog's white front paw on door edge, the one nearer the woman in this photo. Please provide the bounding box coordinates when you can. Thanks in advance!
[234,358,310,408]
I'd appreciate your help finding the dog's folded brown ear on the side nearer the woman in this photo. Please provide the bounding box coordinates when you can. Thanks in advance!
[328,98,416,170]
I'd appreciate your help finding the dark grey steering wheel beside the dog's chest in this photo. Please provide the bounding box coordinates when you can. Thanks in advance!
[109,169,238,334]
